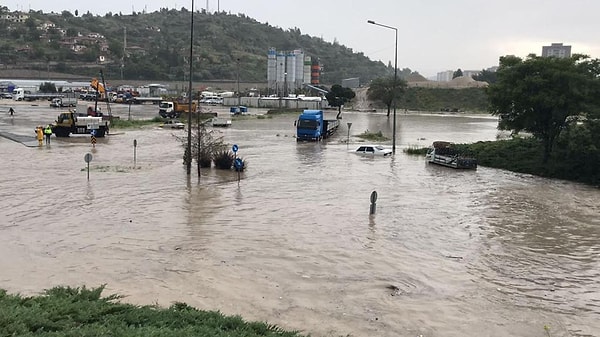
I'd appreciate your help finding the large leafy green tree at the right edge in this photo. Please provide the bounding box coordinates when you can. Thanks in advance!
[487,55,599,163]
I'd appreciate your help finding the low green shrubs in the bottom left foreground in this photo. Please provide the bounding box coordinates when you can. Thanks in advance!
[0,286,300,337]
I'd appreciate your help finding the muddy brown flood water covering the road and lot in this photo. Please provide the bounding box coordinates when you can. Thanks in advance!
[0,101,600,337]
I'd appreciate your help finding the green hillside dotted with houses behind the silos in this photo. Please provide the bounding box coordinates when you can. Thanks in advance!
[0,6,418,84]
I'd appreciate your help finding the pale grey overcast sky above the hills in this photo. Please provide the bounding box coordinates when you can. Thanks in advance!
[2,0,600,77]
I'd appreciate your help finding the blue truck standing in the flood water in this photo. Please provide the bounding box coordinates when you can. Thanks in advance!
[294,110,340,142]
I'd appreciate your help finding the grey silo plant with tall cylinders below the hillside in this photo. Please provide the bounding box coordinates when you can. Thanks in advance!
[267,48,321,97]
